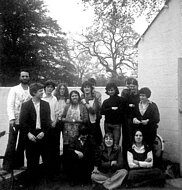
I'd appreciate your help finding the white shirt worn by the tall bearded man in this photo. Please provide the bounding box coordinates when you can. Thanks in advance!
[7,84,31,125]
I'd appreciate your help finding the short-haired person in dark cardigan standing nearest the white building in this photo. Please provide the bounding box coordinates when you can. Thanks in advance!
[133,87,160,148]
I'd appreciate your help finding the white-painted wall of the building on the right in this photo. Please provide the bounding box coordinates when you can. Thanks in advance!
[138,0,182,162]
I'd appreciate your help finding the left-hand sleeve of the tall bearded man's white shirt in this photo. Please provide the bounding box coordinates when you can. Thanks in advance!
[7,88,16,121]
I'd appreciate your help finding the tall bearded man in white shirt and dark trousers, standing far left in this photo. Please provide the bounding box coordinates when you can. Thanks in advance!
[3,70,31,171]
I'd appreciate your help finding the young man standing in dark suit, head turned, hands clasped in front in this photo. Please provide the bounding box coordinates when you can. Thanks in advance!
[20,83,51,183]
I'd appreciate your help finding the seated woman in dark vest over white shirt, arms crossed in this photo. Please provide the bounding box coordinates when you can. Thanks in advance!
[127,129,164,187]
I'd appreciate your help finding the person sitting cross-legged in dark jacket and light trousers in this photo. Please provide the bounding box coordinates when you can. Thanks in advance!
[91,133,128,190]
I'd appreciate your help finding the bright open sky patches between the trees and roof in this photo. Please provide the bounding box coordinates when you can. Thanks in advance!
[44,0,147,34]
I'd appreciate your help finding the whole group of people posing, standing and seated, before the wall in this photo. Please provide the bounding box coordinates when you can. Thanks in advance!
[3,70,164,190]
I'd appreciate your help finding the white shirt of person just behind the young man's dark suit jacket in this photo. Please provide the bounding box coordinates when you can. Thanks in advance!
[42,94,57,122]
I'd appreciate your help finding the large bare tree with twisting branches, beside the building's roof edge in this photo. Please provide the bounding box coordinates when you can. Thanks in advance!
[75,3,139,78]
